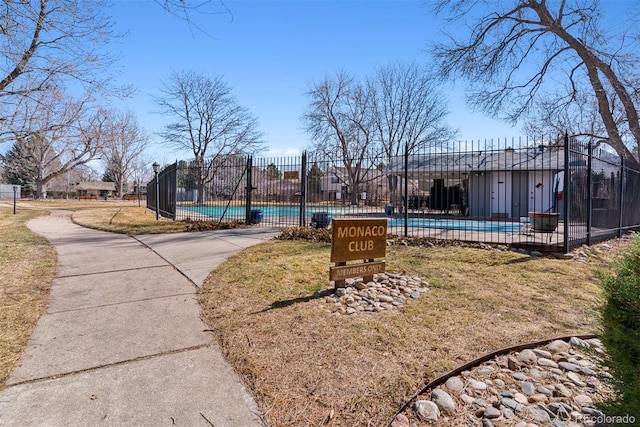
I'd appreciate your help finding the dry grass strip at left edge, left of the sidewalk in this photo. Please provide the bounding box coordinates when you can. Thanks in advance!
[0,205,56,389]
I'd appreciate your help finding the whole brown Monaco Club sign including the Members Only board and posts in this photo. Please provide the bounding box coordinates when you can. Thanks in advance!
[329,218,387,289]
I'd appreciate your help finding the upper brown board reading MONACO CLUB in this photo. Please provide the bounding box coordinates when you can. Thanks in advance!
[331,218,387,262]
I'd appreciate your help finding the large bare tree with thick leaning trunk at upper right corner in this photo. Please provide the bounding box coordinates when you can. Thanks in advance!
[434,0,640,165]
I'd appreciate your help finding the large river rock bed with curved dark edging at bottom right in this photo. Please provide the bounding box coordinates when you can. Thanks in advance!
[391,337,615,427]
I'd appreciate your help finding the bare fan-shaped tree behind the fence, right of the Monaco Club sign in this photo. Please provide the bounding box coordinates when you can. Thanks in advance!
[368,62,456,206]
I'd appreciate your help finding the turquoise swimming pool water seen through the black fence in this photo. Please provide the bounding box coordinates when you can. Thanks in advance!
[181,205,522,233]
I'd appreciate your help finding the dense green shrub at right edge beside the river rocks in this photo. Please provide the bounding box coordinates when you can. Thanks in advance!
[600,237,640,420]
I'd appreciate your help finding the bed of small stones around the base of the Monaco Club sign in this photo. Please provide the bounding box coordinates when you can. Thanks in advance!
[319,273,429,315]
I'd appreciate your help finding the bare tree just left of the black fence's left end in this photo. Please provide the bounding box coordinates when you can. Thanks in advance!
[102,111,148,197]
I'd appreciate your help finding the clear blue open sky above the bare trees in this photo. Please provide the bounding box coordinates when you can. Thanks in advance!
[111,0,519,160]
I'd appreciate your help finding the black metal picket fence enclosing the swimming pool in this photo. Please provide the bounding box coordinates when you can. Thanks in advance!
[147,137,640,252]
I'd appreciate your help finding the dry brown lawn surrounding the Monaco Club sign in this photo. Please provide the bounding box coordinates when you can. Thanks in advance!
[199,241,624,426]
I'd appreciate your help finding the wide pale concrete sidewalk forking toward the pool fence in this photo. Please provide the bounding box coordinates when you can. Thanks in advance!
[0,211,276,427]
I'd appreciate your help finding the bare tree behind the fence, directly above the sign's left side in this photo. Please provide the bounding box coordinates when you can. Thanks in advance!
[302,71,379,204]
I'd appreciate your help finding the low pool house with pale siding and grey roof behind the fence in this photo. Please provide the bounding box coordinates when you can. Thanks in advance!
[386,146,564,220]
